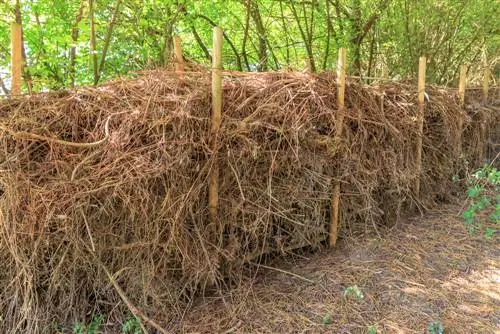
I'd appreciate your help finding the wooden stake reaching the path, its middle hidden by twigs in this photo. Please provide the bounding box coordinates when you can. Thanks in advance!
[328,48,346,247]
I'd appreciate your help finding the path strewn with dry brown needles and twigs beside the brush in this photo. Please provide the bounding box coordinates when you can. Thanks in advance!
[178,206,500,334]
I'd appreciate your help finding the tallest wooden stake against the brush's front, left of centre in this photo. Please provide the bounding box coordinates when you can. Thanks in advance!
[208,27,222,224]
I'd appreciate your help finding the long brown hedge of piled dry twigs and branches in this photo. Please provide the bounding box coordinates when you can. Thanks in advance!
[0,71,498,332]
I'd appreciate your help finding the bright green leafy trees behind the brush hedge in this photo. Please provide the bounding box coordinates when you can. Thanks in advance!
[0,0,500,94]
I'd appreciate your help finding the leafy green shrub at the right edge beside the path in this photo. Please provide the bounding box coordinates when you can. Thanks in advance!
[462,165,500,238]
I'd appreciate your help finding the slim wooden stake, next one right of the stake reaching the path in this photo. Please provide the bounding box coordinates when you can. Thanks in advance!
[415,57,427,198]
